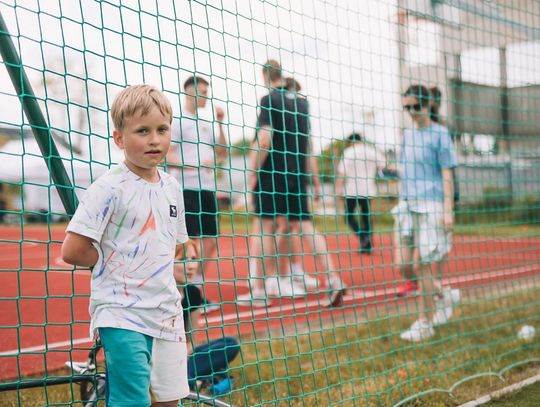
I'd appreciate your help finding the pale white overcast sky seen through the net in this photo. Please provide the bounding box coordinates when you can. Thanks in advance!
[0,0,540,161]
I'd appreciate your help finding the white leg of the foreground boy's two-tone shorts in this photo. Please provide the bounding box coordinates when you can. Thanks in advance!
[150,338,189,401]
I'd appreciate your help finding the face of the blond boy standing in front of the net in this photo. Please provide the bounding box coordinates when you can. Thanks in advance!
[113,107,171,178]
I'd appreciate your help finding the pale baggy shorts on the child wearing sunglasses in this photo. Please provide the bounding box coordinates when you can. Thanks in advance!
[392,204,452,263]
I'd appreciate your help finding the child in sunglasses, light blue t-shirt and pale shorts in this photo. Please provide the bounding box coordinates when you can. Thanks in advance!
[393,85,459,342]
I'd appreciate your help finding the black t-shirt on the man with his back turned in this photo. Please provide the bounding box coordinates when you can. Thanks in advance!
[257,88,310,192]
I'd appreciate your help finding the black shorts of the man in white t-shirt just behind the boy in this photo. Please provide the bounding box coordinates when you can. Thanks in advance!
[184,189,218,238]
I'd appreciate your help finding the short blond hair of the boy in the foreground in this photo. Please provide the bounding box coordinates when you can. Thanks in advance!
[111,85,172,131]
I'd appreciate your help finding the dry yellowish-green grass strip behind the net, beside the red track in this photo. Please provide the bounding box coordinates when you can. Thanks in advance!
[0,287,540,406]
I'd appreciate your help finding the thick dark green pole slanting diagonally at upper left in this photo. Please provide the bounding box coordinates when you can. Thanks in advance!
[0,13,77,216]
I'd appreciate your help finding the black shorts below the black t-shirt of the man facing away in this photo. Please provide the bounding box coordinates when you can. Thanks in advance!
[253,191,311,220]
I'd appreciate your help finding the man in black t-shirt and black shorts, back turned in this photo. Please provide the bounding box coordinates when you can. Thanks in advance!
[240,60,345,306]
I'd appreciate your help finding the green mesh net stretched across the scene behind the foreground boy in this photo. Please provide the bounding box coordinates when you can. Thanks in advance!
[0,0,540,406]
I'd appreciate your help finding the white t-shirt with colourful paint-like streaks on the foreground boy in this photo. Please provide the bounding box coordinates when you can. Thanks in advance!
[67,164,188,341]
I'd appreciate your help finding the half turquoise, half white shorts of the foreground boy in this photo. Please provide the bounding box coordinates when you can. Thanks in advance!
[99,328,189,407]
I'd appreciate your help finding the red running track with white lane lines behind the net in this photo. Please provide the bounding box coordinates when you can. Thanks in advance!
[0,226,540,381]
